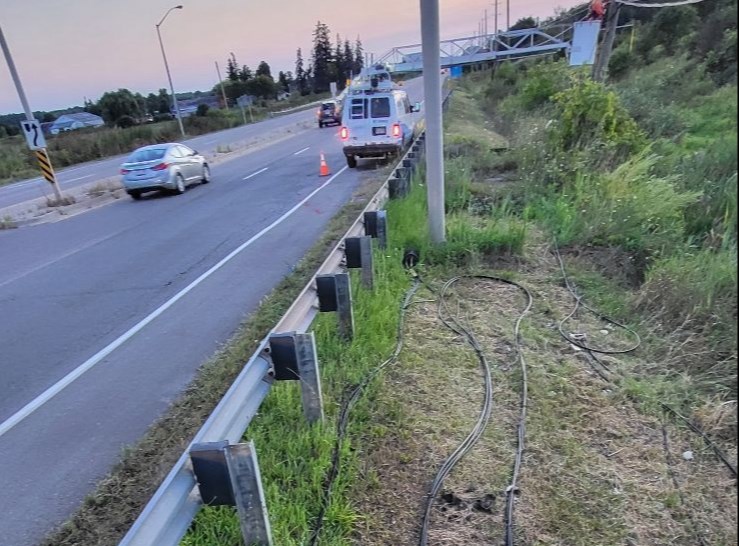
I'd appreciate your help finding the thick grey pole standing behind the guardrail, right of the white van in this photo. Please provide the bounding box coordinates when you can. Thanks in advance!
[420,0,446,243]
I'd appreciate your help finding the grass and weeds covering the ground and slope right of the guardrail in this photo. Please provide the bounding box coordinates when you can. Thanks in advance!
[39,0,737,546]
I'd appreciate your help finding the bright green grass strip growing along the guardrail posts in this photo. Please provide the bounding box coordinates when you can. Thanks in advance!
[182,243,410,546]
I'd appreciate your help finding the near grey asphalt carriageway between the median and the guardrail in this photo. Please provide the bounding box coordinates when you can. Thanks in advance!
[0,80,421,546]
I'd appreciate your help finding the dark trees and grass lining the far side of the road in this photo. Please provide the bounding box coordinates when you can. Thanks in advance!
[0,21,365,186]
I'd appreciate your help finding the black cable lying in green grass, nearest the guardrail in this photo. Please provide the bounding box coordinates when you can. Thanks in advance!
[308,273,421,546]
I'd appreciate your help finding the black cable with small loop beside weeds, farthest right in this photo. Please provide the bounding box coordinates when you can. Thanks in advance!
[554,241,737,479]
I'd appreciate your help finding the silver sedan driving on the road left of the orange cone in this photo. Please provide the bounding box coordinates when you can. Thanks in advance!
[121,143,210,199]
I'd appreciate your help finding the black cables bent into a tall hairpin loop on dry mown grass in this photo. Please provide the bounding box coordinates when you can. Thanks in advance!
[420,275,533,546]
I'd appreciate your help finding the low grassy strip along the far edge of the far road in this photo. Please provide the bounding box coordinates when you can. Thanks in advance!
[0,95,325,185]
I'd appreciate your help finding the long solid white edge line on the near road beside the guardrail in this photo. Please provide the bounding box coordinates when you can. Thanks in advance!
[0,166,348,437]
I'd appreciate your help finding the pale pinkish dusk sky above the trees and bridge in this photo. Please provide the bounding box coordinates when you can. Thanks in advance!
[0,0,583,113]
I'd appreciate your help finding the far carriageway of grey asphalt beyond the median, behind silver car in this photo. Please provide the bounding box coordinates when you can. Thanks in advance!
[0,103,316,209]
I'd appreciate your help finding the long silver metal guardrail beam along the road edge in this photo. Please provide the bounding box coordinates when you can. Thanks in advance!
[119,126,428,546]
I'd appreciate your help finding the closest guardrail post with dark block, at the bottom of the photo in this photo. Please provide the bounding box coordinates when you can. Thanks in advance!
[190,440,272,546]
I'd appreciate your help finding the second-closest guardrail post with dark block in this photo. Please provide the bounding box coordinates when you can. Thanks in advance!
[269,332,323,424]
